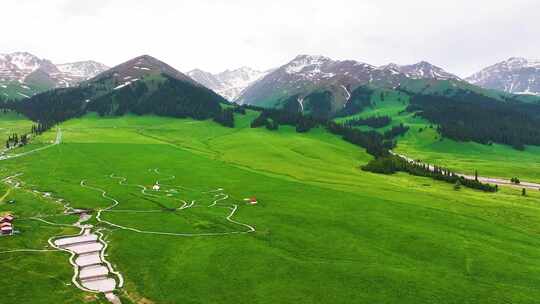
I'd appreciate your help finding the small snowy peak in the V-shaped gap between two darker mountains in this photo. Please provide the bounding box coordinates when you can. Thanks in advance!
[187,67,268,101]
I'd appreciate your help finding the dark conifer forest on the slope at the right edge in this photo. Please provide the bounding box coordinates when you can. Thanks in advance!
[407,91,540,150]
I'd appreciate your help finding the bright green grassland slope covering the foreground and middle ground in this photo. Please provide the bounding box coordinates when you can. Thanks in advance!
[0,110,540,304]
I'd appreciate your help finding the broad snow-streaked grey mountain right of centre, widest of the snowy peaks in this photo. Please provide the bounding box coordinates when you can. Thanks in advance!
[237,55,459,111]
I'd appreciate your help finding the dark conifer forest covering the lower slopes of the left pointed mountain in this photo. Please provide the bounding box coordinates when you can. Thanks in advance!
[2,74,234,131]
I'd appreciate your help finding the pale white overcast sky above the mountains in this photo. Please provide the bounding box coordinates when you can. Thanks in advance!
[0,0,540,76]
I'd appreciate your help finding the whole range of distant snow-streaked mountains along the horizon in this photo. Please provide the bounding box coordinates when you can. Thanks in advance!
[0,52,540,107]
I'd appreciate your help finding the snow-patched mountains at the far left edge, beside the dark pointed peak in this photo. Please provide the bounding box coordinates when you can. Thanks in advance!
[0,52,108,98]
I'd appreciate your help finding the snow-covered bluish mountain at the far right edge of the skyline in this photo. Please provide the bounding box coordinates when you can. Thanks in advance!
[465,57,540,95]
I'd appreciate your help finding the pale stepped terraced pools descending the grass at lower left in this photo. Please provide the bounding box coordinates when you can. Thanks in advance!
[51,214,123,304]
